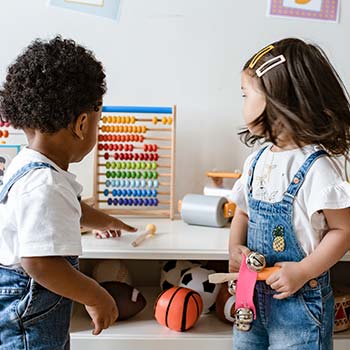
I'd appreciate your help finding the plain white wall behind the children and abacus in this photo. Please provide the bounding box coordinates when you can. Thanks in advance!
[0,0,350,201]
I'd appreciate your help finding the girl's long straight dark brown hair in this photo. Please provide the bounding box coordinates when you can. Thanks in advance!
[239,38,350,155]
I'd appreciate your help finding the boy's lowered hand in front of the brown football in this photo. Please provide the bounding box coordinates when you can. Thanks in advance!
[85,287,119,335]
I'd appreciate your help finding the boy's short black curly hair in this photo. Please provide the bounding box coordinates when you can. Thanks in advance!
[0,36,106,133]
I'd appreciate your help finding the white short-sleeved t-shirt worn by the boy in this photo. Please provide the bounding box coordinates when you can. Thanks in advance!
[0,148,82,266]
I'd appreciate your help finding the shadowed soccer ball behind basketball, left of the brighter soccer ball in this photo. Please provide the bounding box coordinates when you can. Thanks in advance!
[160,260,200,290]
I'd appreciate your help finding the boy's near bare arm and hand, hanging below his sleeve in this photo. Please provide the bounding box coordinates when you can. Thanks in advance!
[21,256,118,335]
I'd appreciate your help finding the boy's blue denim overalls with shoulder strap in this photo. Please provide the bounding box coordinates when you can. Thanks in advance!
[0,162,79,350]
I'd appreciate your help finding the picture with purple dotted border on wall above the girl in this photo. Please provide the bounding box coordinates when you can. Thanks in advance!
[267,0,339,22]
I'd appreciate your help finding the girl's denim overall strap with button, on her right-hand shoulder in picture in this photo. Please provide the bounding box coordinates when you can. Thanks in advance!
[283,150,328,204]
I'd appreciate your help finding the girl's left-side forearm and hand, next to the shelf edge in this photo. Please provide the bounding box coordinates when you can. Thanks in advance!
[229,207,250,272]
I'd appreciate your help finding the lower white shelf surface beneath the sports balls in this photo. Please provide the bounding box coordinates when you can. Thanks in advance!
[71,287,350,350]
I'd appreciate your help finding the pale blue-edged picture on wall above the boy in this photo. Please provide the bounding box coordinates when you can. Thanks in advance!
[48,0,120,20]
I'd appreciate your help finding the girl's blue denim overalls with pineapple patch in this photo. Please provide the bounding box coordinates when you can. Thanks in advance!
[233,148,334,350]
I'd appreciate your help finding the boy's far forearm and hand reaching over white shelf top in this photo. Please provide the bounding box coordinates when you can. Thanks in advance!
[80,201,137,237]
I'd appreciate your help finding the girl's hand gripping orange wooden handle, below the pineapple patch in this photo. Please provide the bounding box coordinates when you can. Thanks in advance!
[266,262,309,299]
